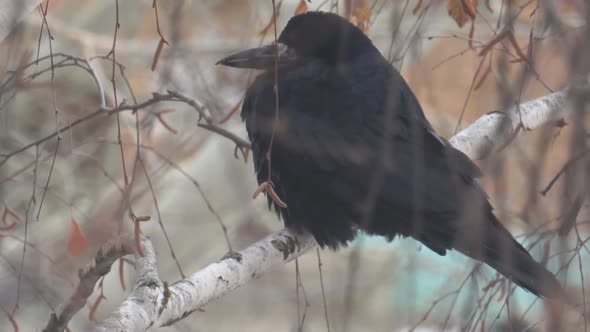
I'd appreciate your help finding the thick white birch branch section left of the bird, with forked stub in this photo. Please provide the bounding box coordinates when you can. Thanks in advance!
[94,229,316,332]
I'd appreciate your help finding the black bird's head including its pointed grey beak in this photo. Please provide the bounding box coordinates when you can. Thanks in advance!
[217,12,378,69]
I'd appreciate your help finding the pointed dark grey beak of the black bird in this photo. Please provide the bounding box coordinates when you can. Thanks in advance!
[217,43,299,69]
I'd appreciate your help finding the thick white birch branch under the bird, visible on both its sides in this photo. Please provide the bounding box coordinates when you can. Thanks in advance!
[83,90,568,332]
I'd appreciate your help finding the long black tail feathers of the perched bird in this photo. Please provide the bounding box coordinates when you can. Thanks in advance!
[456,211,565,298]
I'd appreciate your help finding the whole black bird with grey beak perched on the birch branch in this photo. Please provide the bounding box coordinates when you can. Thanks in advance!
[219,12,562,297]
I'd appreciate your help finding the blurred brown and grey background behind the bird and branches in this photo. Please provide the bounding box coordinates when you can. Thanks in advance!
[0,0,590,331]
